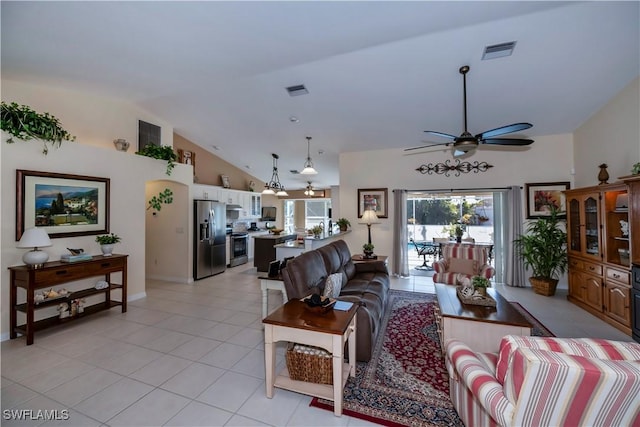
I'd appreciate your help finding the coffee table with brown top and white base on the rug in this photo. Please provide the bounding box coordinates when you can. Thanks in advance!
[435,283,533,353]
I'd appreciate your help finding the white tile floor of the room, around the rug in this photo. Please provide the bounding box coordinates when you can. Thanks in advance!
[0,264,630,426]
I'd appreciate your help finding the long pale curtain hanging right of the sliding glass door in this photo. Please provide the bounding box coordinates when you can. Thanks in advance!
[505,185,527,288]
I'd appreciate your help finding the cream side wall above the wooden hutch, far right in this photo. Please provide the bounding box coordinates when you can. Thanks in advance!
[573,78,640,187]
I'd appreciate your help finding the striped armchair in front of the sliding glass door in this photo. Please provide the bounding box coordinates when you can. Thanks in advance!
[433,243,496,285]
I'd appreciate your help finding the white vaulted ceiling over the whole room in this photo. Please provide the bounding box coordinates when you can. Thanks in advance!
[1,0,640,189]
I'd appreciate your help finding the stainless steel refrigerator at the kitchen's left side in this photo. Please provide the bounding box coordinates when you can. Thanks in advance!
[193,200,227,280]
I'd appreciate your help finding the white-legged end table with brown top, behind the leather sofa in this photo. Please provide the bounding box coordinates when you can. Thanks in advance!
[262,299,358,416]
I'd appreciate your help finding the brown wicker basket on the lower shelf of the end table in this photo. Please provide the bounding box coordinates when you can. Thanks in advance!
[285,343,333,385]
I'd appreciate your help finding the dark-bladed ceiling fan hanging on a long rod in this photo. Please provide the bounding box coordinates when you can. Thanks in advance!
[404,65,533,157]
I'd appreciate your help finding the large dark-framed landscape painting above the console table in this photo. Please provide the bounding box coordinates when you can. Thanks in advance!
[16,169,110,240]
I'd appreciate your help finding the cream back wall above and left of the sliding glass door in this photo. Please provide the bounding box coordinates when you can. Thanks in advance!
[334,134,573,265]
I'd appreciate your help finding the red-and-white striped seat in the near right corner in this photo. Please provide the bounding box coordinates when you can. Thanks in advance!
[446,335,640,427]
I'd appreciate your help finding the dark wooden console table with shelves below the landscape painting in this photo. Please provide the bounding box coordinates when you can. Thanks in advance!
[9,254,128,345]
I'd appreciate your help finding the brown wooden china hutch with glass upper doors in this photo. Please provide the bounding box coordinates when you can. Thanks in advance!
[565,182,631,335]
